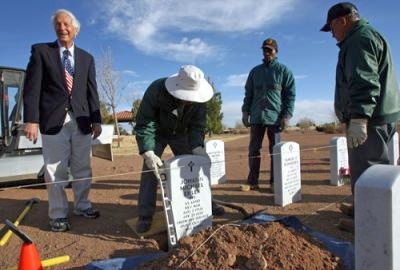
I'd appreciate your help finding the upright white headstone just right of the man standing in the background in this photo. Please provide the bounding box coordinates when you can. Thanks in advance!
[273,142,301,206]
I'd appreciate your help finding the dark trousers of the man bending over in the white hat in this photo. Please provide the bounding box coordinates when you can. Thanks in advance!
[138,136,192,216]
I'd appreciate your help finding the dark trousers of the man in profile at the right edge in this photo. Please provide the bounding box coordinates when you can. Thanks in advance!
[348,123,396,195]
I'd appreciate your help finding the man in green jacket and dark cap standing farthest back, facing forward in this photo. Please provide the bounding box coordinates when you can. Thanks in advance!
[242,38,296,190]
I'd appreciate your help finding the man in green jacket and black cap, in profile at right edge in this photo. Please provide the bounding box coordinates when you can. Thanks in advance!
[321,2,400,230]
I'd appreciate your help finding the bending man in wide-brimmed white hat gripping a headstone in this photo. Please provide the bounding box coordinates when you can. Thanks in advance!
[135,65,224,233]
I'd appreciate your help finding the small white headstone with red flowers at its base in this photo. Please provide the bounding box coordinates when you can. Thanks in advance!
[330,137,349,186]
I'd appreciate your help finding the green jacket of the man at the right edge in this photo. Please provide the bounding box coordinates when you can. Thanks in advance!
[335,19,400,125]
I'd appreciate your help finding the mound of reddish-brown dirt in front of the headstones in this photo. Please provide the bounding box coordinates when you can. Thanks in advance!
[138,222,344,270]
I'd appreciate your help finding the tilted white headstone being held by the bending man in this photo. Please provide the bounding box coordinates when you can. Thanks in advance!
[164,155,212,246]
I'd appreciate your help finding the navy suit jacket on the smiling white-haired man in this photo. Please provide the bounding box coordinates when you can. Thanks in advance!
[23,42,101,135]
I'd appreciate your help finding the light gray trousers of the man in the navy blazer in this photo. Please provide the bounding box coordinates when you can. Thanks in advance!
[42,112,92,219]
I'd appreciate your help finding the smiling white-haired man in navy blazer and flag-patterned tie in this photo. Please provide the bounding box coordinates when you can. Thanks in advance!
[24,9,101,232]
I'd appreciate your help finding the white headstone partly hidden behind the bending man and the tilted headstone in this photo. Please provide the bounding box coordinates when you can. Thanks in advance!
[206,140,225,185]
